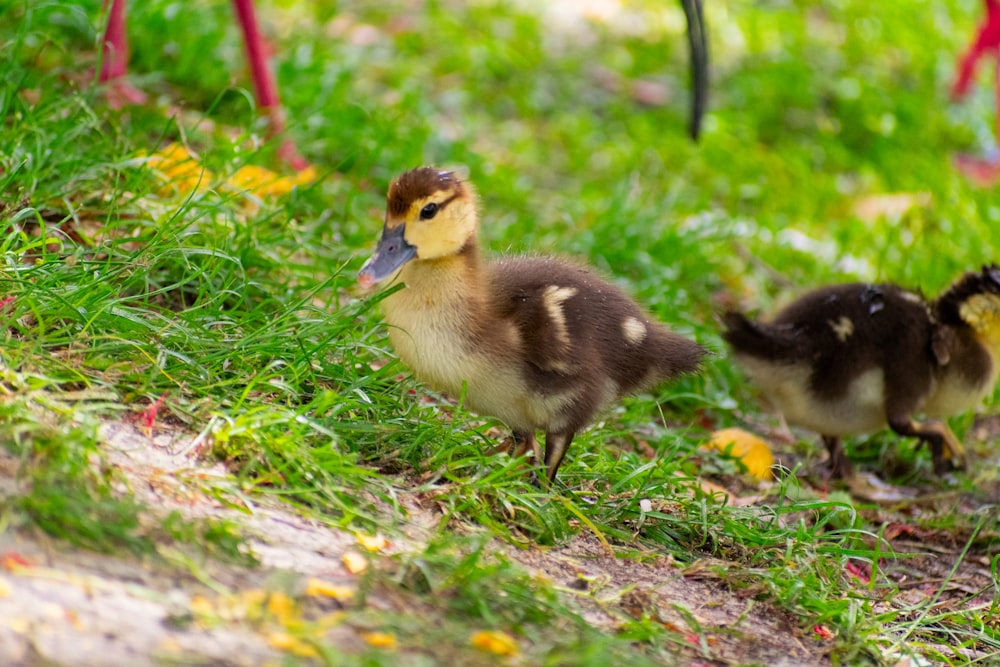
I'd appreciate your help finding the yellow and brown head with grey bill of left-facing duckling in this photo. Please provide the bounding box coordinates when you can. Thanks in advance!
[358,167,478,288]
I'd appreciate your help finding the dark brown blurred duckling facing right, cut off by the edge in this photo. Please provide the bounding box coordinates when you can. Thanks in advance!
[722,265,1000,477]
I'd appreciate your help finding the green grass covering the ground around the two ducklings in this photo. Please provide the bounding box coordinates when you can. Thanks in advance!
[0,0,1000,665]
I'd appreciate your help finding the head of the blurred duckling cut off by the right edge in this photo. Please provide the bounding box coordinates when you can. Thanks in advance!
[937,264,1000,343]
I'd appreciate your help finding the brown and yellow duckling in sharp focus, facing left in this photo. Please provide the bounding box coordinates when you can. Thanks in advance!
[358,167,706,482]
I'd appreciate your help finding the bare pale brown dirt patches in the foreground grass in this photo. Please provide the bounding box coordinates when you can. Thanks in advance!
[0,423,992,667]
